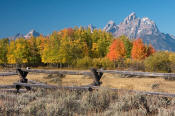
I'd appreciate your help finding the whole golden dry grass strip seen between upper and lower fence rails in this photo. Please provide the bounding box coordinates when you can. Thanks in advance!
[0,73,175,93]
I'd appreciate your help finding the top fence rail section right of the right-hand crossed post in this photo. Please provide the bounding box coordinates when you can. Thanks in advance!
[98,69,175,77]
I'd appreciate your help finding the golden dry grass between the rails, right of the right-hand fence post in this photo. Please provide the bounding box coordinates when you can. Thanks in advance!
[102,74,175,93]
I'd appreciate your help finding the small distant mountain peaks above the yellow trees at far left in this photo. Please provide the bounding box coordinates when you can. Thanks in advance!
[9,30,40,40]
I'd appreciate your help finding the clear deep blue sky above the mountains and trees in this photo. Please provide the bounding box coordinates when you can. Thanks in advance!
[0,0,175,38]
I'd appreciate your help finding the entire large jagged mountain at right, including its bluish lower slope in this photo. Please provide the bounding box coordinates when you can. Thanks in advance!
[103,13,175,51]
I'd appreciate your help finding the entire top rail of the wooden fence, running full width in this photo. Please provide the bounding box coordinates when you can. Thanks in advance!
[0,69,175,77]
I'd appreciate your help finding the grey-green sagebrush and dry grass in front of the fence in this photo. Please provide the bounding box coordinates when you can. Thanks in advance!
[0,87,175,116]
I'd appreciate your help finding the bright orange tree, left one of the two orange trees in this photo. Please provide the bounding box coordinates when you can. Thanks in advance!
[107,39,126,61]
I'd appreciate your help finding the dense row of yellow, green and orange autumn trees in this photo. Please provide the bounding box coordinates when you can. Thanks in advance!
[0,27,172,72]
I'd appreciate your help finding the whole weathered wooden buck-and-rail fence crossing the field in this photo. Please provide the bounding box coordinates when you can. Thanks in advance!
[0,68,175,97]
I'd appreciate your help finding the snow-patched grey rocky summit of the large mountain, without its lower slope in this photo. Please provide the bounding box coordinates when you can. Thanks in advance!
[104,12,160,39]
